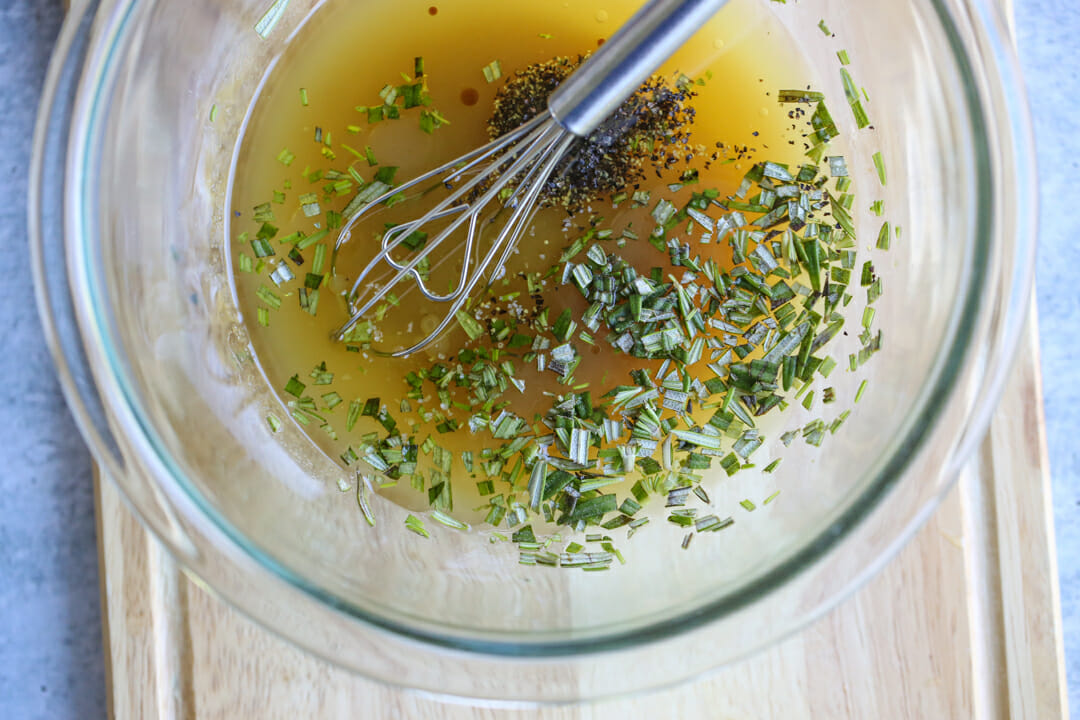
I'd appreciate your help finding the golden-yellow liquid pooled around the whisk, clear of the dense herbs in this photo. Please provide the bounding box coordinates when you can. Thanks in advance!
[229,0,812,522]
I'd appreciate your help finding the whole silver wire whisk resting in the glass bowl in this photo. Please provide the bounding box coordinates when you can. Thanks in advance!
[336,0,727,357]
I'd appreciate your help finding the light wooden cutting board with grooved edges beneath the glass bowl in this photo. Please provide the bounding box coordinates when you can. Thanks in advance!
[97,313,1067,720]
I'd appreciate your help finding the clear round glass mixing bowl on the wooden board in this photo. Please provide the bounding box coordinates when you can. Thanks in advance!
[30,0,1035,702]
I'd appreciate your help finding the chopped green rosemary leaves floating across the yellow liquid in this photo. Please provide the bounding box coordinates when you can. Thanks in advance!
[234,23,885,571]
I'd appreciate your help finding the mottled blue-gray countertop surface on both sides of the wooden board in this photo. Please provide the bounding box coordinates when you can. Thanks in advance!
[0,0,1080,720]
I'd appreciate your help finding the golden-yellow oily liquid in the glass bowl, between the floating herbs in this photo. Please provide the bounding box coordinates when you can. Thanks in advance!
[230,0,812,521]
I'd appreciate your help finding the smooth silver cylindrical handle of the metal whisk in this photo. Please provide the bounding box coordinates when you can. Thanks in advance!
[548,0,727,137]
